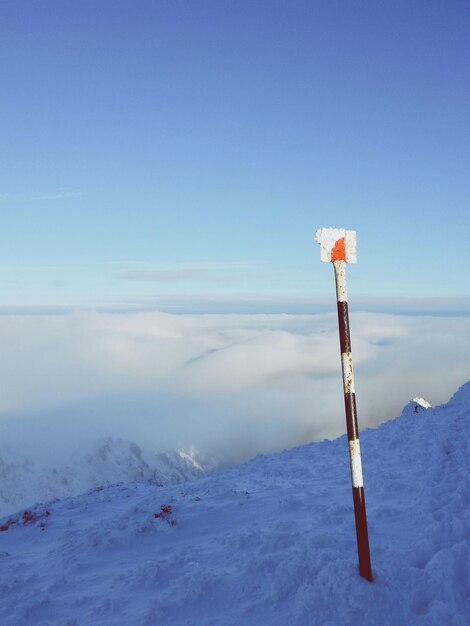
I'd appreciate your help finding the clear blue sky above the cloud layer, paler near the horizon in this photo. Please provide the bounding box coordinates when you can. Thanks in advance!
[0,0,470,313]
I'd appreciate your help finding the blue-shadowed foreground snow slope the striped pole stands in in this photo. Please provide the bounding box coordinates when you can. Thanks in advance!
[0,383,470,626]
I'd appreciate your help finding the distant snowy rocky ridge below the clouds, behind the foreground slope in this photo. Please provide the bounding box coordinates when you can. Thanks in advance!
[0,437,217,515]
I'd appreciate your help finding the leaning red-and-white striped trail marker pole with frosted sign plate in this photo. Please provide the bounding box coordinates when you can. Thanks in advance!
[315,228,373,582]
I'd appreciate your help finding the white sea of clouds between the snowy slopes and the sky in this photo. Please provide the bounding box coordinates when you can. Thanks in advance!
[0,312,470,463]
